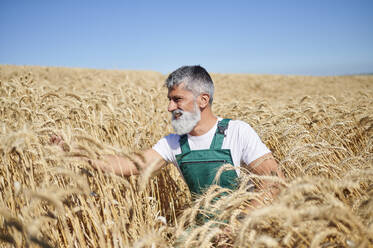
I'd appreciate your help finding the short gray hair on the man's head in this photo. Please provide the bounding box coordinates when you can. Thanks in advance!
[166,65,214,105]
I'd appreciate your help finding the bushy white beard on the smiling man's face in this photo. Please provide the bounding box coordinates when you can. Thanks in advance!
[171,102,201,135]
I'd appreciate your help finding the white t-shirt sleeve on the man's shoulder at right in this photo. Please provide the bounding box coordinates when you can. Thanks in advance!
[240,122,271,165]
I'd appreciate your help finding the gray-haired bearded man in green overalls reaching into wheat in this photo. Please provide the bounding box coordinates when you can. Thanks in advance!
[77,66,283,201]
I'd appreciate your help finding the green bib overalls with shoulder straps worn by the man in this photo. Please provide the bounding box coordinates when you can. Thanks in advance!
[176,119,237,197]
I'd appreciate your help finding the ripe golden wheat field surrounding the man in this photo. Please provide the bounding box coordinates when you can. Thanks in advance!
[0,65,373,247]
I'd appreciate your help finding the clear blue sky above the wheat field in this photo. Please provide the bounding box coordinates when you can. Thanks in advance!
[0,0,373,75]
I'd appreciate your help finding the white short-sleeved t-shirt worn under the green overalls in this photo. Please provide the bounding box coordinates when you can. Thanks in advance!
[153,118,271,174]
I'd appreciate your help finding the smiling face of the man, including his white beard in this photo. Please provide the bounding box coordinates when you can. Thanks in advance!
[168,84,201,135]
